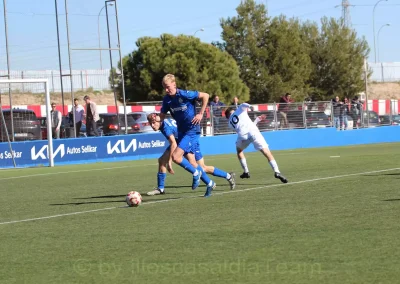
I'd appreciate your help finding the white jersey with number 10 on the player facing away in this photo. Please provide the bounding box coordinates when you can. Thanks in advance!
[228,103,260,136]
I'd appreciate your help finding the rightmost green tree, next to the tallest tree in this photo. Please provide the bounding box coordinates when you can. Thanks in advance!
[302,18,369,100]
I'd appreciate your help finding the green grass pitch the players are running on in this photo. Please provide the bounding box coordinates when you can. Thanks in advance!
[0,144,400,284]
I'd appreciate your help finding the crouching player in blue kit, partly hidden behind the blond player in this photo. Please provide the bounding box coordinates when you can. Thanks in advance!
[147,113,236,195]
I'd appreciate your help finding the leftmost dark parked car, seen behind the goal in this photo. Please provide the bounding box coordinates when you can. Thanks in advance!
[0,109,42,142]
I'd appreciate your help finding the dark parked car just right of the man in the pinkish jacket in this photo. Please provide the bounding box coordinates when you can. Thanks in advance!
[97,113,140,135]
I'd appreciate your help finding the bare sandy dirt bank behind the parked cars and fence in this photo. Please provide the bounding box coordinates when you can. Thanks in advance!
[1,83,400,105]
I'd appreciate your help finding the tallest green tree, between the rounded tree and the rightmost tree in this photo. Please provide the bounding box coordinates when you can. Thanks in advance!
[215,0,311,102]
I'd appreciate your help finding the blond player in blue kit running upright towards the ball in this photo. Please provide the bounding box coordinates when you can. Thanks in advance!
[160,74,216,197]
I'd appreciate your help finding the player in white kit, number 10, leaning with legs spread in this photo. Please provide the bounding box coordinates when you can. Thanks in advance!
[225,103,288,183]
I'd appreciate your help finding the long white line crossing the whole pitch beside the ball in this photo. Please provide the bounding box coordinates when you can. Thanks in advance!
[0,168,400,225]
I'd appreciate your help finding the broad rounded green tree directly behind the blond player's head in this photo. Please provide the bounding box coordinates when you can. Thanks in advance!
[115,34,249,102]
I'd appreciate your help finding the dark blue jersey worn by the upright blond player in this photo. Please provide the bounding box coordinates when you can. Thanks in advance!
[161,89,200,135]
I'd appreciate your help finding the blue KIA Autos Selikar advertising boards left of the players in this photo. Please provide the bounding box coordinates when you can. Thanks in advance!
[0,133,168,168]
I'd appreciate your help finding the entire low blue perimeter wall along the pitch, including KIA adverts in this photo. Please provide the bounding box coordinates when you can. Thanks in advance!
[0,126,400,168]
